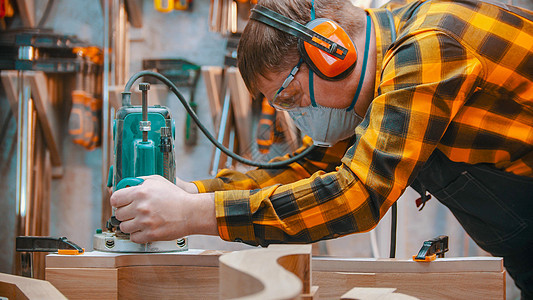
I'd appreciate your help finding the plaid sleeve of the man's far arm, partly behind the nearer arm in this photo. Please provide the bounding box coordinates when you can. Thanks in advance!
[193,136,353,193]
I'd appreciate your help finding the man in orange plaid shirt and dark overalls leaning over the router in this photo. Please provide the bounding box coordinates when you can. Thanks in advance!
[111,0,533,298]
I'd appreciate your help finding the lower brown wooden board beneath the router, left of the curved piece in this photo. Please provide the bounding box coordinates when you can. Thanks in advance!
[46,266,219,300]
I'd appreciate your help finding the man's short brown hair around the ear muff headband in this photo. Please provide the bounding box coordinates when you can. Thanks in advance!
[237,0,364,95]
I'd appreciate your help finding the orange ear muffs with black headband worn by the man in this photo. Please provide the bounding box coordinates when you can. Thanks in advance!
[250,5,357,80]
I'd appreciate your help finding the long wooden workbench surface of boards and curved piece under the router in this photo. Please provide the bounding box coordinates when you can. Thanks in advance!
[42,245,505,300]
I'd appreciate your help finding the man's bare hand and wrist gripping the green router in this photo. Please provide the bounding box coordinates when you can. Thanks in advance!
[110,175,218,243]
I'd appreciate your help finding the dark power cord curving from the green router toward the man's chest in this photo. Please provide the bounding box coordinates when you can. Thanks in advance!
[122,71,316,169]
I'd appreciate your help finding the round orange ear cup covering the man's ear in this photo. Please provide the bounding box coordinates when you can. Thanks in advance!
[298,18,357,80]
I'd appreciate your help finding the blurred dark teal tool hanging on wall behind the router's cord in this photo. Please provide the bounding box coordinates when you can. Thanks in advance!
[143,58,201,146]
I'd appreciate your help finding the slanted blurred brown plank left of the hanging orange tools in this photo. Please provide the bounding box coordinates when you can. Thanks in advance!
[25,71,62,167]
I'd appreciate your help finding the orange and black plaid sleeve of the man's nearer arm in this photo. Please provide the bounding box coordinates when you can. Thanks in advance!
[215,31,481,245]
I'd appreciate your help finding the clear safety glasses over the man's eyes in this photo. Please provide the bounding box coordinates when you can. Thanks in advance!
[269,59,304,110]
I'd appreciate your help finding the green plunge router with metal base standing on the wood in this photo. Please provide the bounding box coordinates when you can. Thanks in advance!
[93,83,188,252]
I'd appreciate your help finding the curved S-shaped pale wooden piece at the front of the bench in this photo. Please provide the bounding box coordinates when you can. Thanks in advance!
[219,245,311,299]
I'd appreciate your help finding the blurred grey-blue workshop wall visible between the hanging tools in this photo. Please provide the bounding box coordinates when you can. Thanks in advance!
[0,0,533,295]
